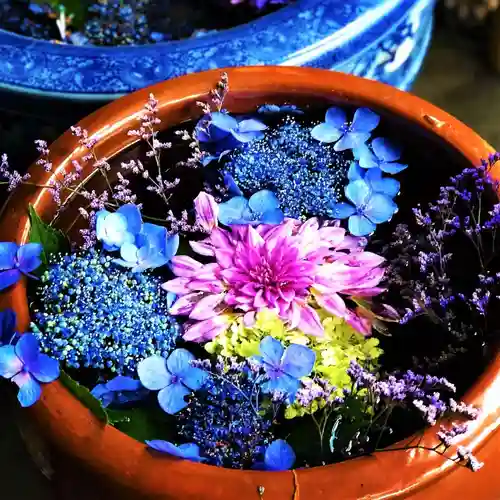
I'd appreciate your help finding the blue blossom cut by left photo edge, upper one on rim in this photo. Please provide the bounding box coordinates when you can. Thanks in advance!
[0,242,42,290]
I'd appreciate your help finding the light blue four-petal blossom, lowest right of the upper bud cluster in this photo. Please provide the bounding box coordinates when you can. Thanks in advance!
[332,179,398,236]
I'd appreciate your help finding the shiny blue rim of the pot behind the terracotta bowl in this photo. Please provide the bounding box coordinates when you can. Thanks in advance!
[0,0,428,96]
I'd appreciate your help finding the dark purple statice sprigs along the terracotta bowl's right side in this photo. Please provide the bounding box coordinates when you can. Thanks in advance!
[382,158,500,366]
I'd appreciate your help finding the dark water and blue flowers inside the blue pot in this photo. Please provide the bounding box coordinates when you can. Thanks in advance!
[0,0,291,46]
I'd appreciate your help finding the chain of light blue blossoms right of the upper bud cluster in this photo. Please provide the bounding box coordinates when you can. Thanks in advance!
[311,107,407,236]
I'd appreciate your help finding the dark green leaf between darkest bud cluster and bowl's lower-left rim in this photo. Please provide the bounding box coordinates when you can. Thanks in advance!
[107,407,175,442]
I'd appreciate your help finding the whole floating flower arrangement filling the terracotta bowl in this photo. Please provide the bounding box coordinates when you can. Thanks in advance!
[0,75,500,471]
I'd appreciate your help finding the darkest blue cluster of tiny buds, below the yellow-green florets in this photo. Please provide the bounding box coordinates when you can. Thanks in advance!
[177,362,272,469]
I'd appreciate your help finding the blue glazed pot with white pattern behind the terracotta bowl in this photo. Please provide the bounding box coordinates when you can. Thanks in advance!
[0,0,434,102]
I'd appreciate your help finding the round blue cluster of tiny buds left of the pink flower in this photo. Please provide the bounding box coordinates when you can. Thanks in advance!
[34,250,181,375]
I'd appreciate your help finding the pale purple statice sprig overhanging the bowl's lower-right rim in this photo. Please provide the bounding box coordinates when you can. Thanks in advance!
[348,361,482,471]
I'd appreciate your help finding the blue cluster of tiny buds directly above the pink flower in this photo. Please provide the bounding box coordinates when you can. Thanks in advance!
[225,117,349,218]
